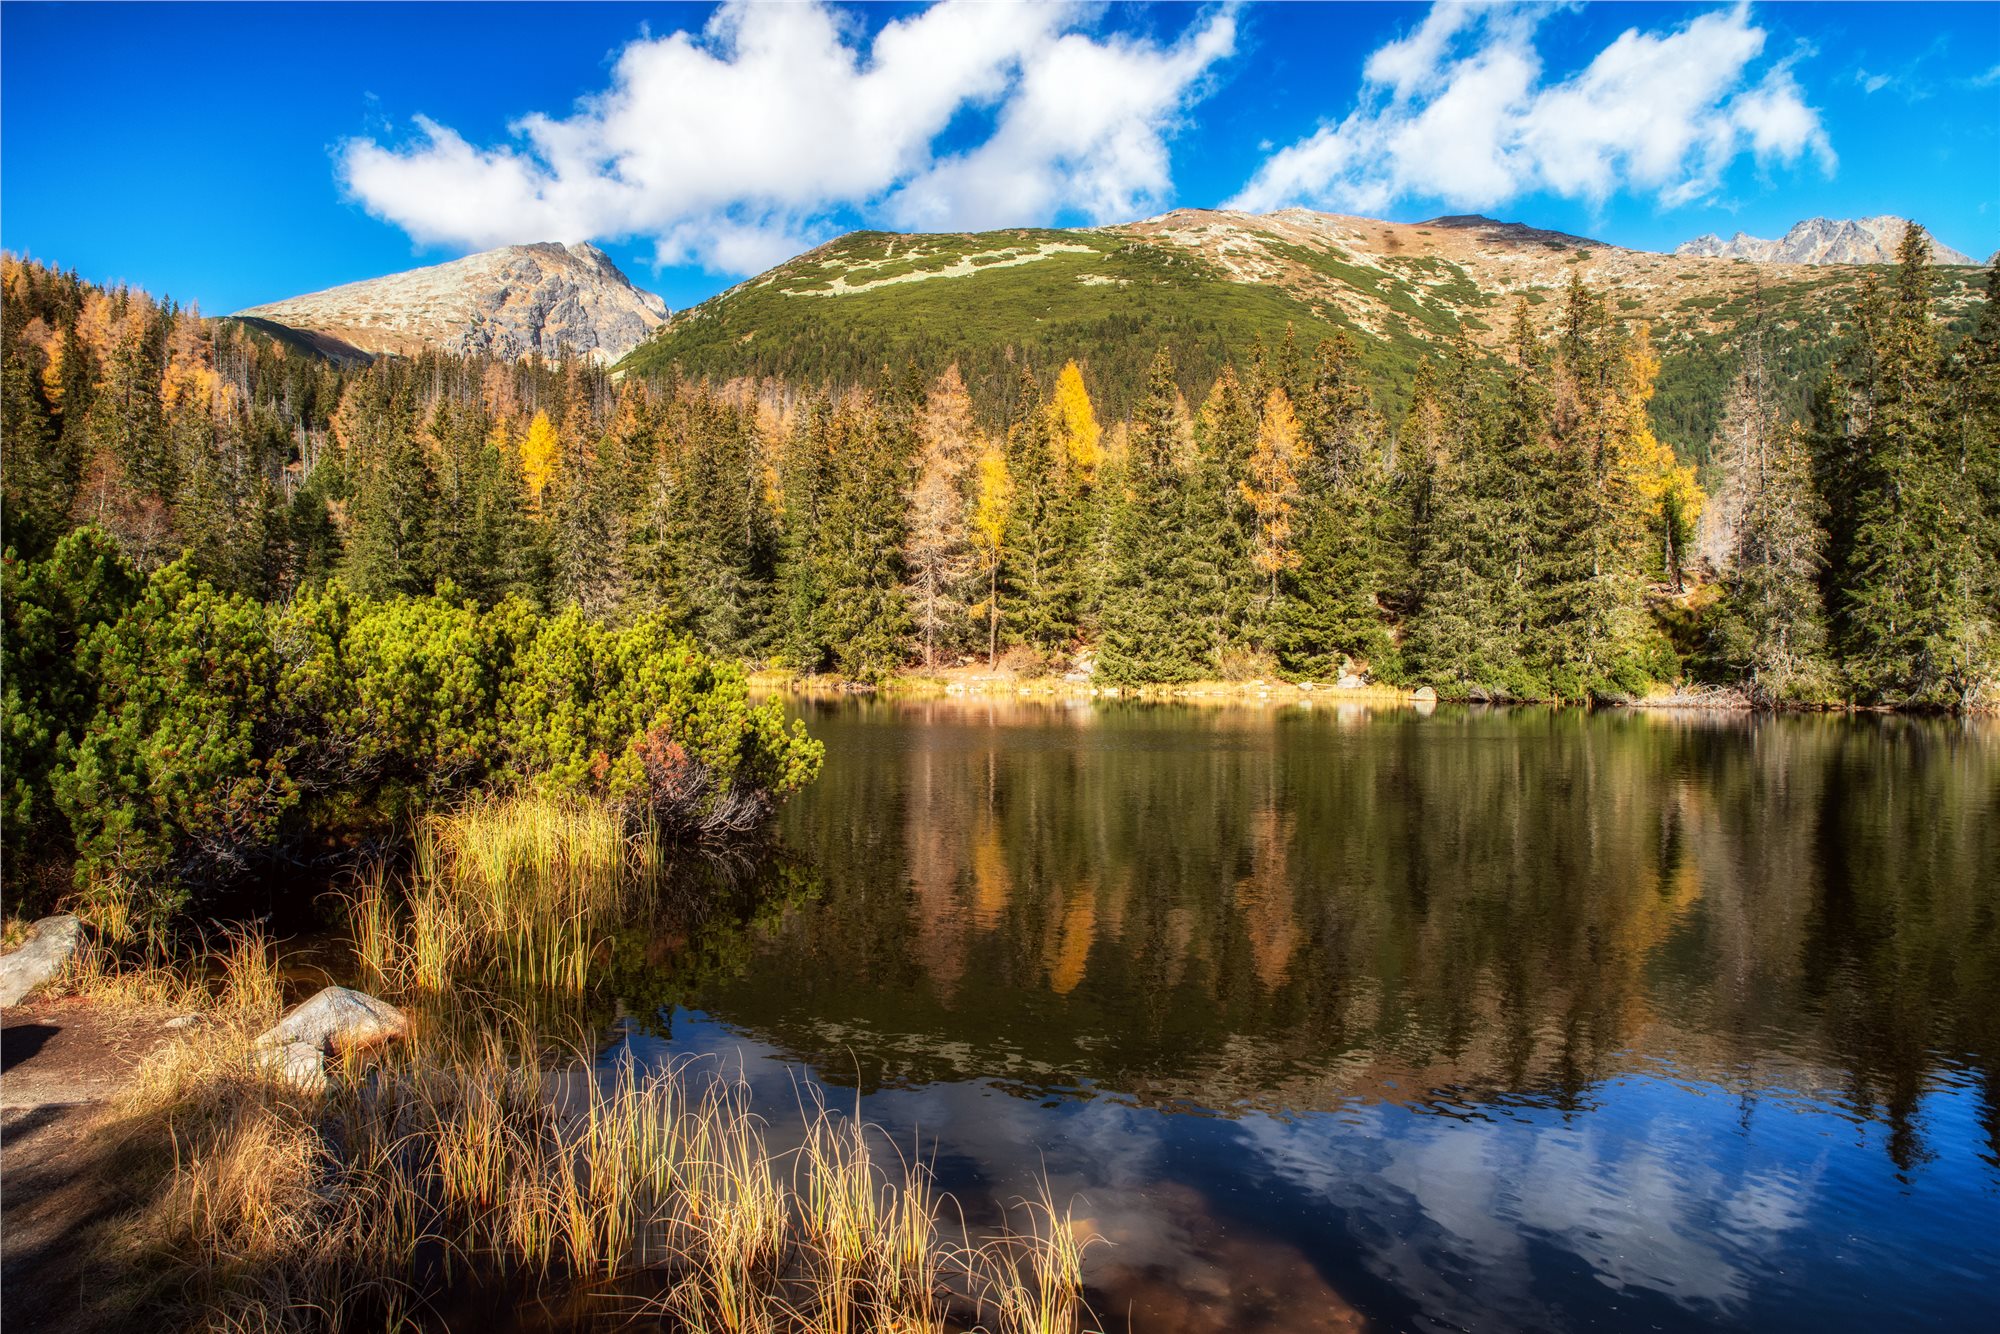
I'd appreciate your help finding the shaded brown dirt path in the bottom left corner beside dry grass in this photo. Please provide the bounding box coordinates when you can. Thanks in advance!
[0,1000,170,1334]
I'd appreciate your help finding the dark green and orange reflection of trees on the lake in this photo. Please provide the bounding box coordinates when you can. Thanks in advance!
[680,702,2000,1166]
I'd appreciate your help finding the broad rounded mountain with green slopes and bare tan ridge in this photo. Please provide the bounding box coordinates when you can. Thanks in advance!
[622,208,1982,442]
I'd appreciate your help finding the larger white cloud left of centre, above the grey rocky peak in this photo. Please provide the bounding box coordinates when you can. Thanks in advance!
[340,0,1236,274]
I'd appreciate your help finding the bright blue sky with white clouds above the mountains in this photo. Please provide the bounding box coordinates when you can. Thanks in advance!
[0,0,2000,312]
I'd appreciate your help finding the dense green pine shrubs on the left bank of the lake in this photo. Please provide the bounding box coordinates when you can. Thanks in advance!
[6,528,822,920]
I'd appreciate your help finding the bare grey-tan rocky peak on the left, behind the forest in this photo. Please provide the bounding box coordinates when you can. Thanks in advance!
[234,242,668,362]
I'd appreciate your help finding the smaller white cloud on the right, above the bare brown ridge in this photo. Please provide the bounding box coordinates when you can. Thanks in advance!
[1230,2,1834,212]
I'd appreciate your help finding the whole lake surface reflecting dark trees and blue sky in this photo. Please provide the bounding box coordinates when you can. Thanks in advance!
[606,700,2000,1334]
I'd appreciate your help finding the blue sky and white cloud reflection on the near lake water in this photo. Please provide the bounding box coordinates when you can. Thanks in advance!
[630,1012,1992,1332]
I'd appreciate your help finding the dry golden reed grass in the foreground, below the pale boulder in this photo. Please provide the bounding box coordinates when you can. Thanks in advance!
[130,1016,1084,1334]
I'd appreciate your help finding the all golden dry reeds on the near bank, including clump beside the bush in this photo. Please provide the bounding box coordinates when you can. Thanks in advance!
[107,802,1088,1334]
